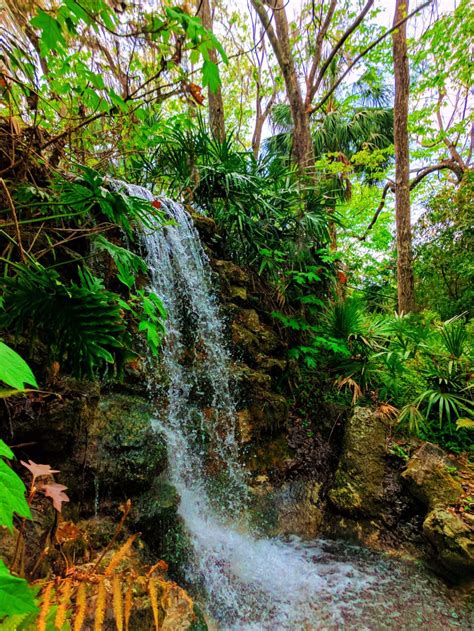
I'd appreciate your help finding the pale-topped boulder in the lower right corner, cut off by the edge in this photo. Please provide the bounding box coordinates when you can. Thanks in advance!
[423,507,474,580]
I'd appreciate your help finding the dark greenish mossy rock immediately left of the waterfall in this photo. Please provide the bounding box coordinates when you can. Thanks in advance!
[97,394,166,496]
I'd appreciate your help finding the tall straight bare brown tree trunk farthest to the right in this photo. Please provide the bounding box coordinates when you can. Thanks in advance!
[392,0,415,313]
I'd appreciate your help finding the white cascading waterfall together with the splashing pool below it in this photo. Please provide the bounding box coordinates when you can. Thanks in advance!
[108,183,470,631]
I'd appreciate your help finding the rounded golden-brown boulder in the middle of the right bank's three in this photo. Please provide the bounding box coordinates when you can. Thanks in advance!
[402,443,463,509]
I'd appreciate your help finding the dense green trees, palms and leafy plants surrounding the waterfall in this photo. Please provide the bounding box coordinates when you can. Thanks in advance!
[0,0,474,628]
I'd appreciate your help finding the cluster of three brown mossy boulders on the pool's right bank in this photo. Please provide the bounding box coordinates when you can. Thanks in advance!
[325,408,474,580]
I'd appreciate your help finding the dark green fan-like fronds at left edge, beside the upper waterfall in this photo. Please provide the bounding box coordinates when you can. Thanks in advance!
[0,265,125,376]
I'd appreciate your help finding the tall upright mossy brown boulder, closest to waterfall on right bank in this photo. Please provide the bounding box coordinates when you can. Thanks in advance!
[329,407,387,517]
